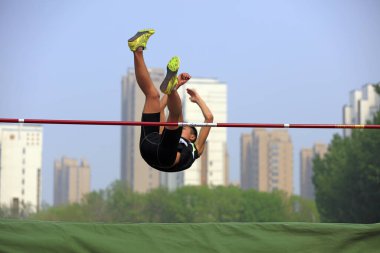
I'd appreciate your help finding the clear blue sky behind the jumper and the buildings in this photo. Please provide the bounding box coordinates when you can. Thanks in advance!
[0,0,380,203]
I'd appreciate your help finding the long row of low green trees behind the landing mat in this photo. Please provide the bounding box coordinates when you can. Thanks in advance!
[31,181,319,223]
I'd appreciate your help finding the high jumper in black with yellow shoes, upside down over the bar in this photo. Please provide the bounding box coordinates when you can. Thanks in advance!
[128,30,213,172]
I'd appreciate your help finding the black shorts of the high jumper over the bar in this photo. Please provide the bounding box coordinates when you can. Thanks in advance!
[140,113,182,171]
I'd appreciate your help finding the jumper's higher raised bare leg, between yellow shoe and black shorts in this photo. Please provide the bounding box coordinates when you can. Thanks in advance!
[133,48,160,113]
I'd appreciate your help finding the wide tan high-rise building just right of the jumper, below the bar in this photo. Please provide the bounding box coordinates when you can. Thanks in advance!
[241,129,293,194]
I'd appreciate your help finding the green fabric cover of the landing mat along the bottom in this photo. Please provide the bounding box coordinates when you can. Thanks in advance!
[0,220,380,253]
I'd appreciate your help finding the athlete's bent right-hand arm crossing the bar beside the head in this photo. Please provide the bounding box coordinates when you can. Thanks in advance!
[187,89,214,155]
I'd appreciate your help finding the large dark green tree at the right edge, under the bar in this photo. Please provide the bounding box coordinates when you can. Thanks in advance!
[313,109,380,223]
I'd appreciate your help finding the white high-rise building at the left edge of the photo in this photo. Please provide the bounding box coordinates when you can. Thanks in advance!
[0,124,42,214]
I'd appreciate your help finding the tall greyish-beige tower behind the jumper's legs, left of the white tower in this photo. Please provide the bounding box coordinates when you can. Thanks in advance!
[121,68,165,192]
